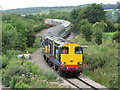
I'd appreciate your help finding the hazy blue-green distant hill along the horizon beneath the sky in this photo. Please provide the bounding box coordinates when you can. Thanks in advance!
[3,4,118,15]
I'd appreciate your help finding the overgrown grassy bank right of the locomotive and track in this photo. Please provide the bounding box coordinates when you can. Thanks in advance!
[75,33,120,88]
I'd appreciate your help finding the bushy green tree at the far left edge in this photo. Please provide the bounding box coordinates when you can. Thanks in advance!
[2,23,18,52]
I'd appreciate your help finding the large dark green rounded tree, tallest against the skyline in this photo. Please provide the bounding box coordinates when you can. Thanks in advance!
[82,4,105,23]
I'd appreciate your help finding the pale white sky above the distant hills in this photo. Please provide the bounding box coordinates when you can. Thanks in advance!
[0,0,120,10]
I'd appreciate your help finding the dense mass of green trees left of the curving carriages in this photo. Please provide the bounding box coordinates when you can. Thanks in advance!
[2,14,48,52]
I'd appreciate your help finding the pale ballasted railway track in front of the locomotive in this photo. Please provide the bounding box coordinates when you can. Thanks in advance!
[64,76,109,90]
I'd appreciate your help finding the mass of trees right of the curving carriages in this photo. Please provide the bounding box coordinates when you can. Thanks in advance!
[70,4,120,45]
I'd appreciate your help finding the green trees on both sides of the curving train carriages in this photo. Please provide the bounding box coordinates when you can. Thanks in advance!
[2,4,120,56]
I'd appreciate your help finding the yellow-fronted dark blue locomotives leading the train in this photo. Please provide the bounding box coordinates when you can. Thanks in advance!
[42,36,83,76]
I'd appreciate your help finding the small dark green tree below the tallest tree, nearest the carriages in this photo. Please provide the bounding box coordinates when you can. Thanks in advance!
[80,23,93,41]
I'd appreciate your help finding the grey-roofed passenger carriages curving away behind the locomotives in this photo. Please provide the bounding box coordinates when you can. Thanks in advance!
[45,19,72,38]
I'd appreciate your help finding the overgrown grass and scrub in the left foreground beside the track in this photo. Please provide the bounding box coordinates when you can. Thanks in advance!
[1,51,63,88]
